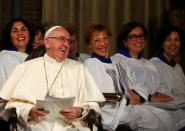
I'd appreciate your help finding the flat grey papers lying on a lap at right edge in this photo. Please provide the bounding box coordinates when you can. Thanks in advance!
[147,99,185,110]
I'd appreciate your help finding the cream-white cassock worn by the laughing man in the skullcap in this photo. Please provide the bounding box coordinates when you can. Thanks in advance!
[0,54,104,131]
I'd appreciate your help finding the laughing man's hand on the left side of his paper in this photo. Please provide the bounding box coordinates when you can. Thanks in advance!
[29,106,49,121]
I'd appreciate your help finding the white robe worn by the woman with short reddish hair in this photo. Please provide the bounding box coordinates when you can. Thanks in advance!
[84,58,173,131]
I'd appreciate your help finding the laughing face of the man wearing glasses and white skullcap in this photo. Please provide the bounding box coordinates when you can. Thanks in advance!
[44,28,70,61]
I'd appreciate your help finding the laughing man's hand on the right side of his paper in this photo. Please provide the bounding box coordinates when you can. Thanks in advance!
[60,107,82,119]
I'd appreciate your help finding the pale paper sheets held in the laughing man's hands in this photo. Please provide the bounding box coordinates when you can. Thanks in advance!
[36,96,75,118]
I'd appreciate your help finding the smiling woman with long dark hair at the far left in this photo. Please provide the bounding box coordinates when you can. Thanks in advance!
[0,18,33,89]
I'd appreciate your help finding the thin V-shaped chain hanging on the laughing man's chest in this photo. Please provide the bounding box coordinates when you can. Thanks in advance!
[43,57,65,93]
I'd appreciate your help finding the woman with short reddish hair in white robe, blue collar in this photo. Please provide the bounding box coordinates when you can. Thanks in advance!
[84,24,173,131]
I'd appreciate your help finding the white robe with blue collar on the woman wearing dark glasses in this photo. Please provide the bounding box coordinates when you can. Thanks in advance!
[111,51,176,130]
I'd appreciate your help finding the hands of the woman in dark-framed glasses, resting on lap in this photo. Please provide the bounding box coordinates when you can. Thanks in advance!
[151,92,173,102]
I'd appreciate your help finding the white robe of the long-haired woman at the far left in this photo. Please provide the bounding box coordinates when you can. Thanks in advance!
[0,50,28,89]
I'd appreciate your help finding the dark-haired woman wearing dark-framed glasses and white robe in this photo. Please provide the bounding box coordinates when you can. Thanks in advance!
[111,22,172,102]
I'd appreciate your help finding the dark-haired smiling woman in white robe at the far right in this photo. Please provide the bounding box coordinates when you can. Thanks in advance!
[150,26,185,129]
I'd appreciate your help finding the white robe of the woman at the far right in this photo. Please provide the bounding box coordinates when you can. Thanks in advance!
[150,57,185,129]
